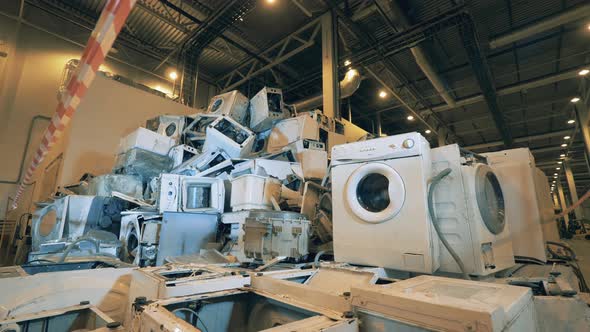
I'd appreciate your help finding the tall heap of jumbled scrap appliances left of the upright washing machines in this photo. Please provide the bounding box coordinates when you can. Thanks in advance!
[28,87,346,266]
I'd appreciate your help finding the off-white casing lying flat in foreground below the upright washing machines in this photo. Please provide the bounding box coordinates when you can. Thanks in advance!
[351,276,539,332]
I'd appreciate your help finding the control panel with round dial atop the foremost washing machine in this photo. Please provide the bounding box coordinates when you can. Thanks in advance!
[332,132,430,163]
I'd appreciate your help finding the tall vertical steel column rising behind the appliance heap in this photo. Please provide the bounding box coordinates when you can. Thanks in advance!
[321,10,340,119]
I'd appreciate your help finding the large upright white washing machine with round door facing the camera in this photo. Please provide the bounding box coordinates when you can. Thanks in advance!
[332,133,439,273]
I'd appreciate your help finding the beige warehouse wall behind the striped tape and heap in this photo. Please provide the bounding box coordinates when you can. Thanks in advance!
[0,16,214,220]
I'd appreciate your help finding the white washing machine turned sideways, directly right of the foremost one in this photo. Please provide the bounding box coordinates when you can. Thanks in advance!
[430,144,514,276]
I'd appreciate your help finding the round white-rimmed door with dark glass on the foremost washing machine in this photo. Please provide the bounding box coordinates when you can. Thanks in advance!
[344,162,406,224]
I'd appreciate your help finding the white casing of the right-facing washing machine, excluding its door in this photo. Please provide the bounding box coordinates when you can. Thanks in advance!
[431,144,514,276]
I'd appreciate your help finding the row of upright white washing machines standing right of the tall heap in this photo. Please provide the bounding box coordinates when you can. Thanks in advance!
[331,133,559,278]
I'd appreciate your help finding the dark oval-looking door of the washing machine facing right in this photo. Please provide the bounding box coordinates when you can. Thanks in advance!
[475,164,506,235]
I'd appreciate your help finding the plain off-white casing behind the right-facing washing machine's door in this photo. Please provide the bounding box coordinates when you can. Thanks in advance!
[483,148,547,262]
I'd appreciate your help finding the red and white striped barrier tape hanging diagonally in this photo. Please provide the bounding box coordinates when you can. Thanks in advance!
[12,0,136,209]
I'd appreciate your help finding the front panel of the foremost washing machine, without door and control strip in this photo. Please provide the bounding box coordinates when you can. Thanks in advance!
[332,153,439,273]
